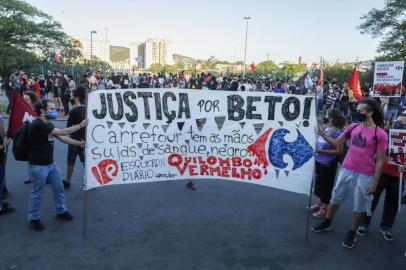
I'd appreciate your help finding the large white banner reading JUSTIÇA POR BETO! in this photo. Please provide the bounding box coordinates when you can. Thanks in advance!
[85,89,316,194]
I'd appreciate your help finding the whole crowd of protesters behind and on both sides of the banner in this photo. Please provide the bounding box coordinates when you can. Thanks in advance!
[0,68,406,255]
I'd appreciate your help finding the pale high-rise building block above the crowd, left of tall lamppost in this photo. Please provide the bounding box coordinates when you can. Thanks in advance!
[130,38,172,68]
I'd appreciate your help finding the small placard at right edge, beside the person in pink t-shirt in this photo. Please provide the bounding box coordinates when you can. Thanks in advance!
[389,129,406,165]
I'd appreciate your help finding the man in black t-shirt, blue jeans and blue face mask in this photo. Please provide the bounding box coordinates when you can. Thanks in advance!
[27,99,88,231]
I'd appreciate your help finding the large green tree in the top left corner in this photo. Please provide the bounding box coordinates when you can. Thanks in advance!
[0,0,66,75]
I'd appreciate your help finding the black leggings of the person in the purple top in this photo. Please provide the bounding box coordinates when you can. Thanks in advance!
[314,161,337,204]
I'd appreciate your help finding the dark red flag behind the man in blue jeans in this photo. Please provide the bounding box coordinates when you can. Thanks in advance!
[7,91,37,138]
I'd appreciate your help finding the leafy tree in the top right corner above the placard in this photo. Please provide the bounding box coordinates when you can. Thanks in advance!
[358,0,406,59]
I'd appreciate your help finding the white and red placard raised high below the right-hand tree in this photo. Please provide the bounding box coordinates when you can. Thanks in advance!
[373,61,404,96]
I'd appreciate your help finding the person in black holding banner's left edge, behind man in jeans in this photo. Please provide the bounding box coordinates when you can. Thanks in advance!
[63,86,86,188]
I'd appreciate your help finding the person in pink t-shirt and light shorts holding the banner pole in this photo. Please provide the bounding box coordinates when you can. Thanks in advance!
[311,99,388,248]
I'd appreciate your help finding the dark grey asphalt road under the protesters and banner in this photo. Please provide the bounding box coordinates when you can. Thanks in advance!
[0,122,406,270]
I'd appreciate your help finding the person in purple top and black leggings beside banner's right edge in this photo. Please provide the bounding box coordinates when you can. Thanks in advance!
[310,109,345,218]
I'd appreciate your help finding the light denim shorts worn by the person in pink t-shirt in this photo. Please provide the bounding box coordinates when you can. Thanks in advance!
[330,168,374,216]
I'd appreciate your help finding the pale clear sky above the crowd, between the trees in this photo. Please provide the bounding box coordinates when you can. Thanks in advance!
[27,0,384,63]
